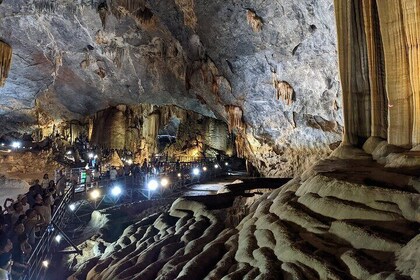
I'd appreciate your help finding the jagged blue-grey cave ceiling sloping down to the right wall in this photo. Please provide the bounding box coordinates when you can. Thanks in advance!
[0,0,343,176]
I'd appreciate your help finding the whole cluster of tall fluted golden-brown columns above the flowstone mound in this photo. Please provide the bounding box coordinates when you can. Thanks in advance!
[335,0,420,147]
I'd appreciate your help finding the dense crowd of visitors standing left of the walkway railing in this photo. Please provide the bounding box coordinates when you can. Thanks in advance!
[0,172,67,280]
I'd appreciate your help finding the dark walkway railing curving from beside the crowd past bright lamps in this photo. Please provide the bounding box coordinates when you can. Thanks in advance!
[23,163,222,280]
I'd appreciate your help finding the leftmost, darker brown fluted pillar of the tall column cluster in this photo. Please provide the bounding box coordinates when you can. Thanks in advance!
[334,0,371,145]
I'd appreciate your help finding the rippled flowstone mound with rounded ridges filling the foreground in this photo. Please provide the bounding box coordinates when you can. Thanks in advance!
[68,146,420,280]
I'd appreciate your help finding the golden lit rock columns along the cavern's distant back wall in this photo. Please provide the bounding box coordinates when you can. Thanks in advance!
[90,104,228,163]
